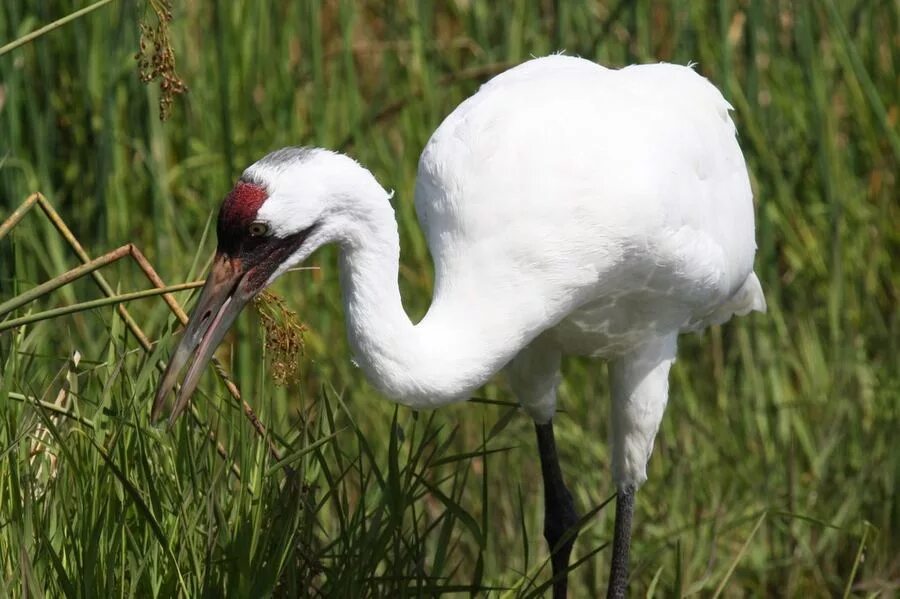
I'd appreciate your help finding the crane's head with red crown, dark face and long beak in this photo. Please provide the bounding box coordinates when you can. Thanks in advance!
[151,148,393,424]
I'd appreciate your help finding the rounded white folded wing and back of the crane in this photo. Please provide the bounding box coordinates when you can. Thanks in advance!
[416,56,762,352]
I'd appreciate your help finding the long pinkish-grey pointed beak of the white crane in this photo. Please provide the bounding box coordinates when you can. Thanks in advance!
[150,253,255,426]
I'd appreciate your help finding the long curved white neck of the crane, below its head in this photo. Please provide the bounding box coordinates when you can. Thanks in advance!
[340,190,518,407]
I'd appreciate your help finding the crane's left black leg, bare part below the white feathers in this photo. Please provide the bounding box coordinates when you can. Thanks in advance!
[534,421,578,599]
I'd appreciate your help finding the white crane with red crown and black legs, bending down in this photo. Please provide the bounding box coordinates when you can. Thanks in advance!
[153,55,765,597]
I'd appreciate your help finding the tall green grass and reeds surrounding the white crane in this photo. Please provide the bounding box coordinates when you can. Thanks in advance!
[0,0,900,597]
